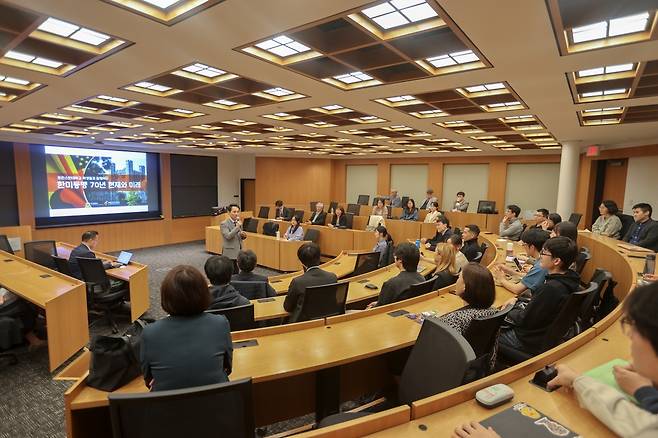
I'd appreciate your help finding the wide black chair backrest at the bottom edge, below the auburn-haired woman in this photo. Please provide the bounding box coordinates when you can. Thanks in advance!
[109,378,255,438]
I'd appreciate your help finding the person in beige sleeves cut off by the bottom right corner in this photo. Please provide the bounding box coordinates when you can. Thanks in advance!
[548,283,658,438]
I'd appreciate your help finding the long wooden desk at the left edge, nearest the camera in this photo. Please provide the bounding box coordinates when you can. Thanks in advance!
[0,251,89,371]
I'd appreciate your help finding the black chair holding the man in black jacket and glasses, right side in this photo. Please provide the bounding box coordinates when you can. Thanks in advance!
[499,283,599,365]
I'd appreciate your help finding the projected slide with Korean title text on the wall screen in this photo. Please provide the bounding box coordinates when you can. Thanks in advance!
[44,146,148,217]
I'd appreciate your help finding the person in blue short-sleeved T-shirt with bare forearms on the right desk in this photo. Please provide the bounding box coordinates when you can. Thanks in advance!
[494,228,550,295]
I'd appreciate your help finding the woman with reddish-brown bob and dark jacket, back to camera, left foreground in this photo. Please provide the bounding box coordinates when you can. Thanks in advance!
[140,266,233,391]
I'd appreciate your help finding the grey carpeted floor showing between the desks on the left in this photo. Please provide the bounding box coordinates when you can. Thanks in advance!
[0,242,283,438]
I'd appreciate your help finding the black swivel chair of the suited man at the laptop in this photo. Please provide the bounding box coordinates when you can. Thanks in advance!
[78,257,128,333]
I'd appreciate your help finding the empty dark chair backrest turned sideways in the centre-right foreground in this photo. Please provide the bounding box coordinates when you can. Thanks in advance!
[398,318,475,404]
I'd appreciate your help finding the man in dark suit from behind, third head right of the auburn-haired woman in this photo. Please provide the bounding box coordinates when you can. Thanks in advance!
[283,242,338,322]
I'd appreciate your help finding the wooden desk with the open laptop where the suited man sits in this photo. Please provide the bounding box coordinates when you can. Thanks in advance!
[57,242,151,321]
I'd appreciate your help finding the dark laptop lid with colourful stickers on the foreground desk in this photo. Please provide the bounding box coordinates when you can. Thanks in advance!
[480,403,579,438]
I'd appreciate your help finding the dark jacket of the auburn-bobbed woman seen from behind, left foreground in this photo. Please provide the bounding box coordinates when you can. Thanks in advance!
[140,313,233,391]
